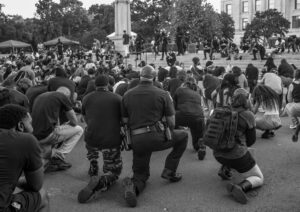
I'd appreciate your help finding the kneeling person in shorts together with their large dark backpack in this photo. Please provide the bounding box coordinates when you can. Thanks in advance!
[203,88,264,204]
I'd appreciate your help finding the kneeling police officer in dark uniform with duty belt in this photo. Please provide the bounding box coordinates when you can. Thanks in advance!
[122,66,188,207]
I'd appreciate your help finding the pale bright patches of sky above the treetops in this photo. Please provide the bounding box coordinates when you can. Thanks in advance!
[0,0,221,18]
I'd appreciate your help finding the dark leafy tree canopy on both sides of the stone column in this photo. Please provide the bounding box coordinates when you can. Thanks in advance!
[0,0,234,48]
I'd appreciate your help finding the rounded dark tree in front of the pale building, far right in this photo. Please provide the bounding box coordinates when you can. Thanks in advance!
[244,9,291,41]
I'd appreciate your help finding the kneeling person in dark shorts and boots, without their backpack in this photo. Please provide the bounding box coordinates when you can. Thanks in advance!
[214,89,264,204]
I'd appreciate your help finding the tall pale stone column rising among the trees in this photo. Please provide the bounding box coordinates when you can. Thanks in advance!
[111,0,131,55]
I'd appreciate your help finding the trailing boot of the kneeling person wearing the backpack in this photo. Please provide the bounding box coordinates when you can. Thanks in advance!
[227,180,252,204]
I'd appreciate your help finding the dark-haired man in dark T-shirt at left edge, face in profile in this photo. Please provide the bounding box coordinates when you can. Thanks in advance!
[0,104,49,212]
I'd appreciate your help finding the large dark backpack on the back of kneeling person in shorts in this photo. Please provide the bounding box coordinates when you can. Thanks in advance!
[203,107,239,151]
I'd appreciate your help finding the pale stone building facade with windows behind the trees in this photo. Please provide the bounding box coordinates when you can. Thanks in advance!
[221,0,300,43]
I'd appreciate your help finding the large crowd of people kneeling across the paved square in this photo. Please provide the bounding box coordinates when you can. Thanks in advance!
[0,52,300,212]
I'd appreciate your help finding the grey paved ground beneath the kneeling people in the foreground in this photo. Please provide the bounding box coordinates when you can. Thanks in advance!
[45,115,300,212]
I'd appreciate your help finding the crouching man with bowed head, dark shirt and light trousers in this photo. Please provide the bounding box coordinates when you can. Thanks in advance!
[32,87,83,172]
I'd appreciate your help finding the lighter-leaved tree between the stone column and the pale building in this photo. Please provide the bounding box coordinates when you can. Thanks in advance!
[172,0,222,40]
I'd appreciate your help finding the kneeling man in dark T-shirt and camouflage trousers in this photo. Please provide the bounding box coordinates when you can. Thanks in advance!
[78,75,123,203]
